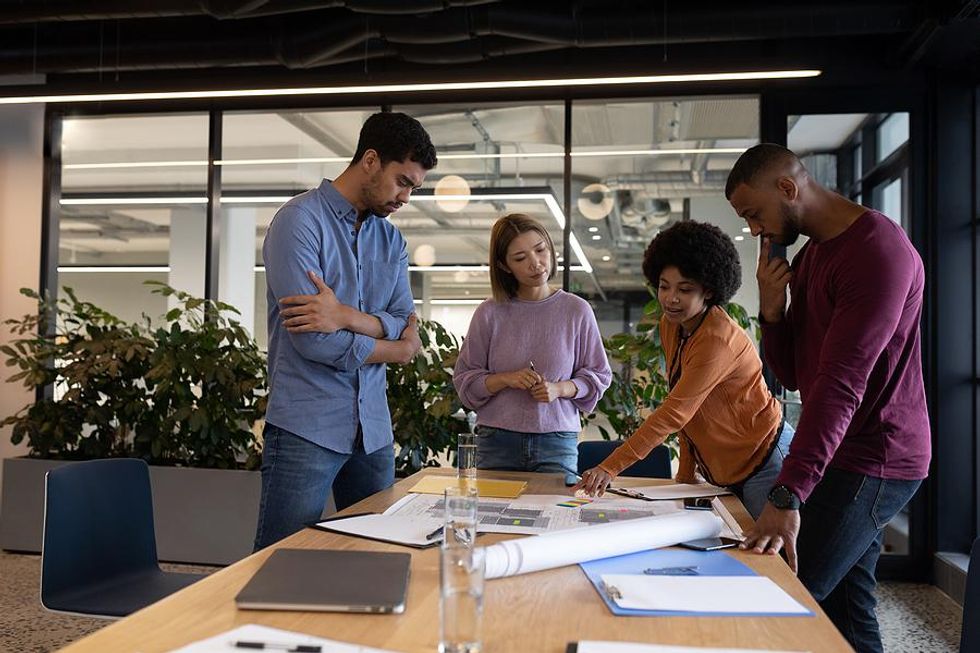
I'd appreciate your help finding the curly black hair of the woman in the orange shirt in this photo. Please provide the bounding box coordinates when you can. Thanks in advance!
[643,220,742,306]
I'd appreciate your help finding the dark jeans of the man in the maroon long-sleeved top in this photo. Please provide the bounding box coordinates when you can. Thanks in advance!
[797,467,922,653]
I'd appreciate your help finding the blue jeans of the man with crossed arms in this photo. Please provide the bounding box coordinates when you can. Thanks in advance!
[255,422,395,551]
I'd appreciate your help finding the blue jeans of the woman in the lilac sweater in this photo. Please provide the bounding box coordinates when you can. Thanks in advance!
[476,426,578,474]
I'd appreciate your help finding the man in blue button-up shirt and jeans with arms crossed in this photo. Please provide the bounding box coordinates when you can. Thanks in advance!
[255,113,436,549]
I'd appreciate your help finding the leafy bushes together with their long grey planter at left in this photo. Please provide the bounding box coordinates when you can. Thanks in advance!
[0,282,266,564]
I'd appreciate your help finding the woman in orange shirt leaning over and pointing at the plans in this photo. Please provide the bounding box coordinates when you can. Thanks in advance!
[576,221,793,518]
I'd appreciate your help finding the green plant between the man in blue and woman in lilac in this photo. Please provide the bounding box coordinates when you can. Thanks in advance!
[387,320,466,475]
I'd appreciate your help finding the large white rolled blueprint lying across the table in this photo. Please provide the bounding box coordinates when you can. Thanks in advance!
[485,511,722,578]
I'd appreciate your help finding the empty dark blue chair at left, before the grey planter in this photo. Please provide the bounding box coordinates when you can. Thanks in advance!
[41,458,202,617]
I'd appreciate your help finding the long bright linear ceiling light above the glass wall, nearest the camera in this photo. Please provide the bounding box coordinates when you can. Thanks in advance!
[0,70,822,104]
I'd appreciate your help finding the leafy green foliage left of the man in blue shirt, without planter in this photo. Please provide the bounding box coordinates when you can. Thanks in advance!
[0,282,266,468]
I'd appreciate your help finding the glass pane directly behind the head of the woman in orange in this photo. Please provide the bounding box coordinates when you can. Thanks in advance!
[571,97,759,326]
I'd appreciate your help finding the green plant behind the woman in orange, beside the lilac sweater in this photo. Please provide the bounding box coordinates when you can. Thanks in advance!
[584,287,758,457]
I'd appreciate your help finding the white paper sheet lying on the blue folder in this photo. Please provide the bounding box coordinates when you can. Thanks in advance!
[602,574,810,615]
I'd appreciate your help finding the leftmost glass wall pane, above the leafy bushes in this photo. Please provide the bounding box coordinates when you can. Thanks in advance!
[58,113,208,326]
